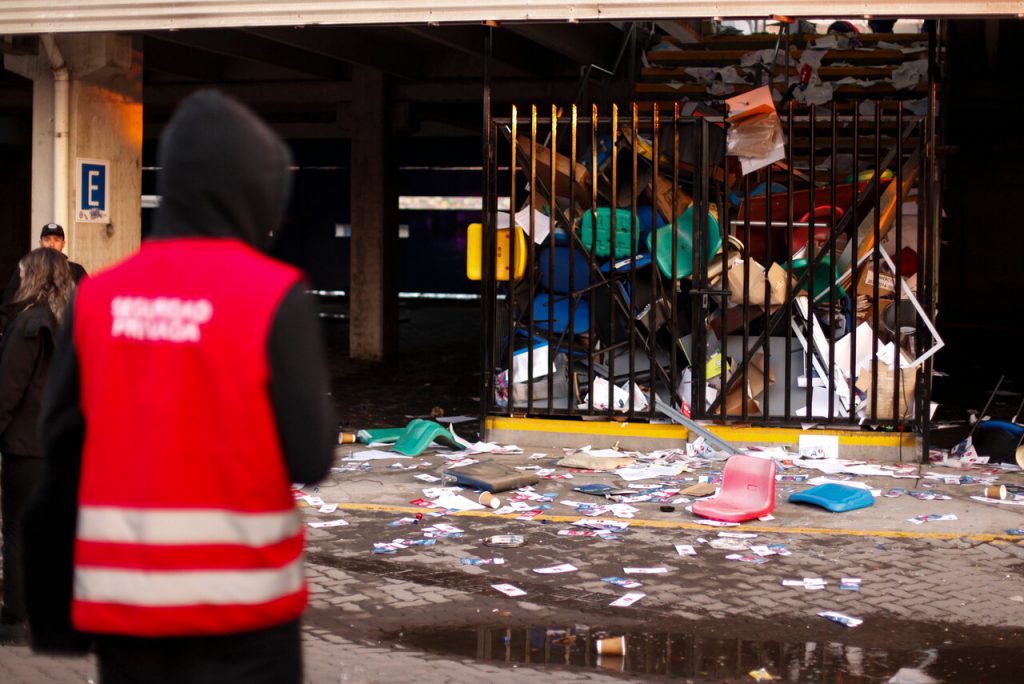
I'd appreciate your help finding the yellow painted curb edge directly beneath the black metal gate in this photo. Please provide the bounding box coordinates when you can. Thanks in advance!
[485,416,915,448]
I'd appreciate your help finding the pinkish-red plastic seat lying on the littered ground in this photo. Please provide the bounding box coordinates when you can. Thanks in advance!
[693,454,775,522]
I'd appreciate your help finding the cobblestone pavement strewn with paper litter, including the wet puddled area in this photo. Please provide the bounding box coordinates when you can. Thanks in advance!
[6,452,1024,684]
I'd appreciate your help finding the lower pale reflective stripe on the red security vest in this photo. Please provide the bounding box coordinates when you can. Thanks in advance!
[75,556,303,607]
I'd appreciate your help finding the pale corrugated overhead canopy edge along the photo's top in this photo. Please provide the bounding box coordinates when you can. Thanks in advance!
[0,0,1024,34]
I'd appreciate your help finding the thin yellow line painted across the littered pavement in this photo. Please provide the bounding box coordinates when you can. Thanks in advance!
[338,504,1020,542]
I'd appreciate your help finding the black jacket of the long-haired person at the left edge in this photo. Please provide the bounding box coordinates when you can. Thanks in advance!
[0,303,57,457]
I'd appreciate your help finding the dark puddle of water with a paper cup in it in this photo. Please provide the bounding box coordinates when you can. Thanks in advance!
[386,627,1024,684]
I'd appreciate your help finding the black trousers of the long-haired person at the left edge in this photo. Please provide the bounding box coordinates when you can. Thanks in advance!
[0,454,43,622]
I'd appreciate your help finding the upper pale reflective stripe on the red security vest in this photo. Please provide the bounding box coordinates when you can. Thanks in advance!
[78,506,301,547]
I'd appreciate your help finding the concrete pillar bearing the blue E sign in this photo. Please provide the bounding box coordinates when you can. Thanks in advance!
[4,33,142,272]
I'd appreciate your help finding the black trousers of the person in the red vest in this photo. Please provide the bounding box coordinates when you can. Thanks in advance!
[96,621,302,684]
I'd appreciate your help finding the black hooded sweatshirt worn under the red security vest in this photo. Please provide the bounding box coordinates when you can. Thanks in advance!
[24,91,336,651]
